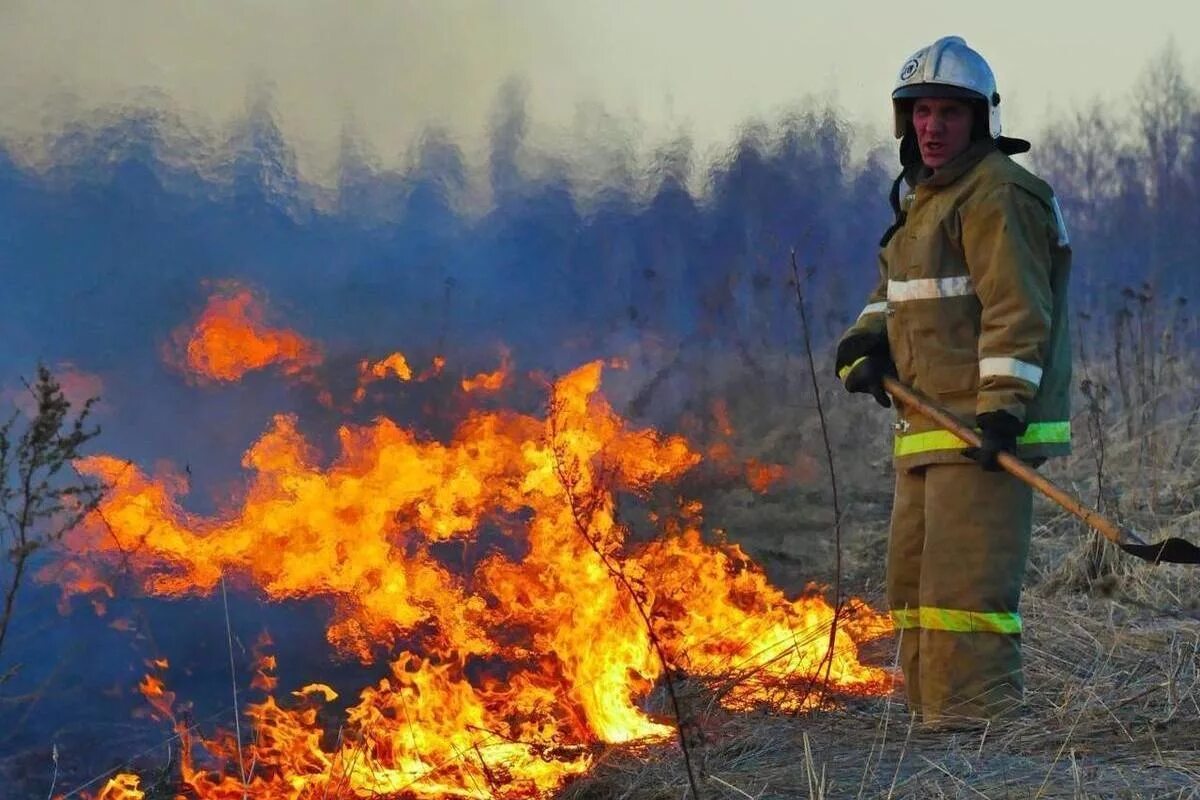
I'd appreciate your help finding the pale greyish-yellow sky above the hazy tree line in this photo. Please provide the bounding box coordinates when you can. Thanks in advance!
[0,0,1200,180]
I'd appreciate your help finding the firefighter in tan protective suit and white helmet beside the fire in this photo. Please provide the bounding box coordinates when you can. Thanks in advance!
[836,36,1070,727]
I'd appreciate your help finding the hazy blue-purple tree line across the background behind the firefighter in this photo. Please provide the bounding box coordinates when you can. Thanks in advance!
[0,48,1200,381]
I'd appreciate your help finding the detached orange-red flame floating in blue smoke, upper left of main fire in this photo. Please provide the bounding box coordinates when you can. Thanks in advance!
[175,285,320,381]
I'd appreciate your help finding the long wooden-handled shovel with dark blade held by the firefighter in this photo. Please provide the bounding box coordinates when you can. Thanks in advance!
[883,377,1200,564]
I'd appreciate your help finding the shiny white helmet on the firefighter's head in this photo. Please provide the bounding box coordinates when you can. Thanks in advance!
[892,36,1000,139]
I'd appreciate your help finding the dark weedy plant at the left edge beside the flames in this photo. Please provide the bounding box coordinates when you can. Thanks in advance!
[0,366,103,684]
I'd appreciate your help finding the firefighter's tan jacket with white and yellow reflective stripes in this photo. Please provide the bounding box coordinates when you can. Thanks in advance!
[838,142,1070,468]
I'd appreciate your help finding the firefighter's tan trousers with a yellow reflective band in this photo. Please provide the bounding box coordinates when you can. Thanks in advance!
[888,464,1033,723]
